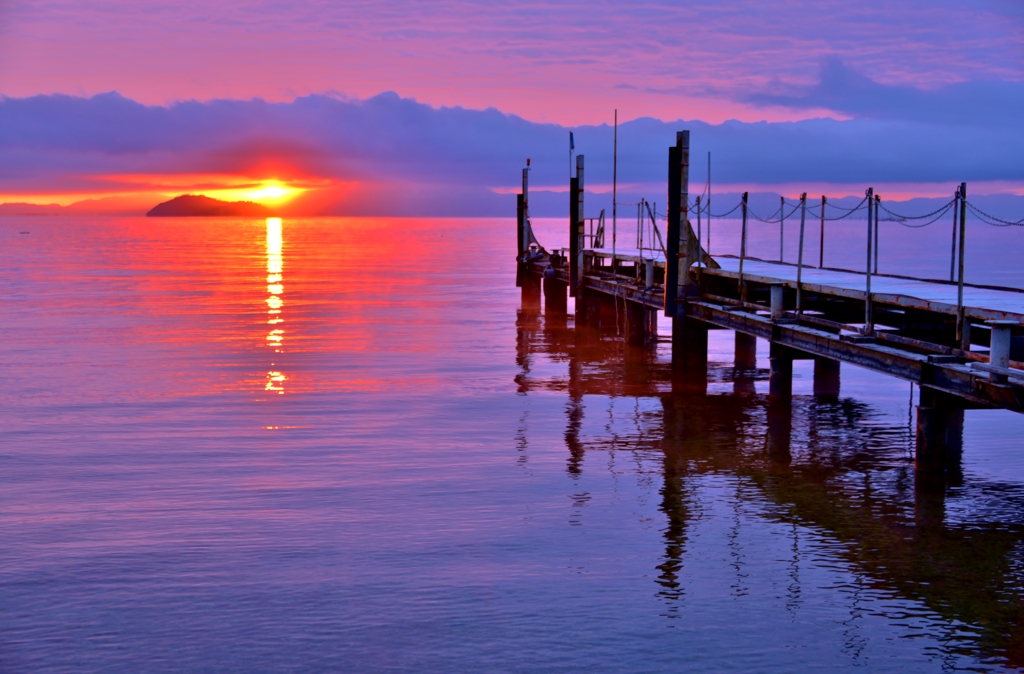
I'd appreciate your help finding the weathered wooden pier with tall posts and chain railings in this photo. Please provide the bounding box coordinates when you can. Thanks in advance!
[516,131,1024,475]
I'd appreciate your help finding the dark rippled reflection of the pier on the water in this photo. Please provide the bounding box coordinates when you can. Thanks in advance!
[516,302,1024,668]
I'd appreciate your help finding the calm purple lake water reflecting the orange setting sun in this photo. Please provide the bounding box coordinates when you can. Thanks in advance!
[6,218,1024,672]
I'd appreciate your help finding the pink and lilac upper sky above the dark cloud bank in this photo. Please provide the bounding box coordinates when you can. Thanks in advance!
[0,0,1024,125]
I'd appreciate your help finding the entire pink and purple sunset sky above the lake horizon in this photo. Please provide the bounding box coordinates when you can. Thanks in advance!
[0,0,1024,214]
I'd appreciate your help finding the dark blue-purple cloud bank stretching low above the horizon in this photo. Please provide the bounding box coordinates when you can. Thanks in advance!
[0,62,1024,217]
